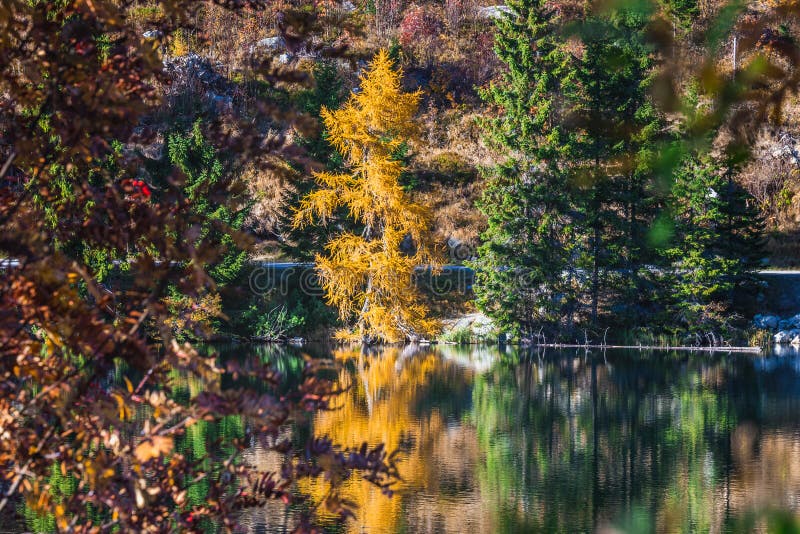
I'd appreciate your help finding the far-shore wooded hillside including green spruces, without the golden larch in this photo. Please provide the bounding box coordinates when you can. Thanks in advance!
[108,0,800,337]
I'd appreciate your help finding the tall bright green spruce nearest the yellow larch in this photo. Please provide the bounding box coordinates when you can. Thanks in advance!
[474,0,576,335]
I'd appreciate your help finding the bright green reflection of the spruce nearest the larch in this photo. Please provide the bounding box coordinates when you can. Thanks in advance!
[472,356,591,532]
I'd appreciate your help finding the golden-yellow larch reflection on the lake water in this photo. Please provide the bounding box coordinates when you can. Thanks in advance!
[302,346,477,532]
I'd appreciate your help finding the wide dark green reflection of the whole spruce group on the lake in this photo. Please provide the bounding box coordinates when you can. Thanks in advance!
[471,355,735,532]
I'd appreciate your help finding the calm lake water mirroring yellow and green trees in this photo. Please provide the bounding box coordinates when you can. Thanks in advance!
[235,346,800,533]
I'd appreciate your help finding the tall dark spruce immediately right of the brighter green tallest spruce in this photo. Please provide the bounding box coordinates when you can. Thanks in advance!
[565,8,661,325]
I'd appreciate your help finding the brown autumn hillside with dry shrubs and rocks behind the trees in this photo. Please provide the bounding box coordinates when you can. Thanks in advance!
[117,0,800,267]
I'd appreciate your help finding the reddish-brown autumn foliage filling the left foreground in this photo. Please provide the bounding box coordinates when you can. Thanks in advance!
[0,0,394,532]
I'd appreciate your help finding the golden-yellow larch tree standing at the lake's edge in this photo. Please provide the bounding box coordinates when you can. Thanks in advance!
[294,50,439,342]
